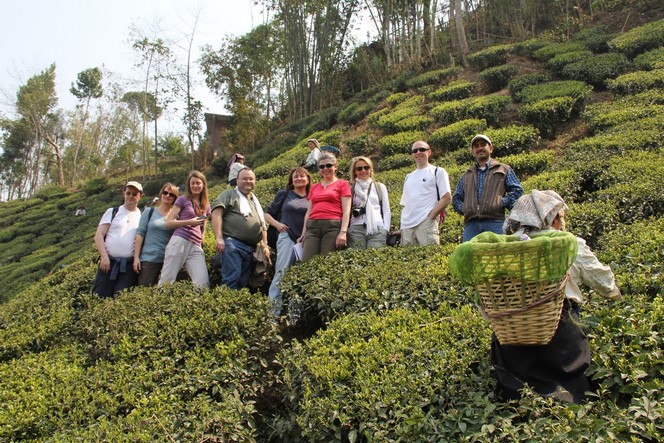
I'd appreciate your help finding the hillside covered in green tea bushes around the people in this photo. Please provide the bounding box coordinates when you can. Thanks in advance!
[0,15,664,442]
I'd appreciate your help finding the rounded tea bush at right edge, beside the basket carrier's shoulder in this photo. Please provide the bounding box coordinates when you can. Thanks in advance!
[599,216,664,299]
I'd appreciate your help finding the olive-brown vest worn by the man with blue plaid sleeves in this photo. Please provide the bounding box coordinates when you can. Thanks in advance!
[462,160,509,223]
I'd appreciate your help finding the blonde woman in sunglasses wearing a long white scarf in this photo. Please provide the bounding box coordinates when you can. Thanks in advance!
[348,156,392,249]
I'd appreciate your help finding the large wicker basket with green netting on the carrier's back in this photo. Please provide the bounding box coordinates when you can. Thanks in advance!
[450,232,577,345]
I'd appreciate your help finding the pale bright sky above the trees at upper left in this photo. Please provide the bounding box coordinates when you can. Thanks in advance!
[0,0,263,130]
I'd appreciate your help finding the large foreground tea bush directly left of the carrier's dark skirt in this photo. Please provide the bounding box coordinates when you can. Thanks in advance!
[279,306,494,441]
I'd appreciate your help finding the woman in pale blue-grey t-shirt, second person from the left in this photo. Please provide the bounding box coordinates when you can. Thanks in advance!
[134,183,178,286]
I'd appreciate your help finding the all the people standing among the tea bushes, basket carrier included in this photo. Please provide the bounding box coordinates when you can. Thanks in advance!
[94,134,620,401]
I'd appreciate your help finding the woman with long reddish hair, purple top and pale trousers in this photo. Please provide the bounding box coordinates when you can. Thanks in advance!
[159,171,211,288]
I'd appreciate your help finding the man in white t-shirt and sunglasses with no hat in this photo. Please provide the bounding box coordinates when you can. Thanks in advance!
[401,140,452,246]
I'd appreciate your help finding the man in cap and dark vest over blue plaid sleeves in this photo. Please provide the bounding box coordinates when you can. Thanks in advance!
[452,134,523,241]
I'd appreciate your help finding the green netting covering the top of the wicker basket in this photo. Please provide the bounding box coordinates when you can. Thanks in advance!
[449,231,578,286]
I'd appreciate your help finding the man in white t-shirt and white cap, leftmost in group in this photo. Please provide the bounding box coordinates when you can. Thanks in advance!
[93,181,143,297]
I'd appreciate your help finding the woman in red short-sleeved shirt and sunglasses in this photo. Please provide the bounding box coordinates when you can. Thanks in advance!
[298,153,351,261]
